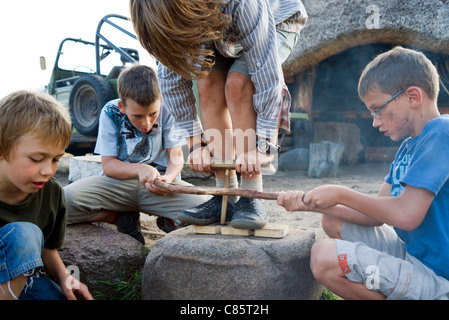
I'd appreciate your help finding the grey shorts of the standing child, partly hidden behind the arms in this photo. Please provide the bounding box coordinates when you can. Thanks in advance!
[212,29,299,77]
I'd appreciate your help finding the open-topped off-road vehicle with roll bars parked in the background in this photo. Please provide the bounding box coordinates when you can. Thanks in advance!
[43,14,139,136]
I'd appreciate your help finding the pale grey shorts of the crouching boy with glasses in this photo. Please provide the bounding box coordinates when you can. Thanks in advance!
[336,222,449,300]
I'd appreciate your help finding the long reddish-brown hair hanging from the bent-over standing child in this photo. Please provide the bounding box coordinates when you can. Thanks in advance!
[130,0,229,79]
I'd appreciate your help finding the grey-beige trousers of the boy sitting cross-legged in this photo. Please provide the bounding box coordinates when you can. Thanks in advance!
[64,176,210,224]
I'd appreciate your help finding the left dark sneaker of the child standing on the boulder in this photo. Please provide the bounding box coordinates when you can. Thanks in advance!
[178,196,234,226]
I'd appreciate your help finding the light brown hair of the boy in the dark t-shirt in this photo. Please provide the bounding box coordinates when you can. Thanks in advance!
[0,91,72,159]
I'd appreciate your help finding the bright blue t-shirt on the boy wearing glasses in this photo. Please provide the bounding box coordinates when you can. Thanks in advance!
[385,115,449,279]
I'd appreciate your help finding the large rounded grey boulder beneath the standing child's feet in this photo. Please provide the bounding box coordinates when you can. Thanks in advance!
[142,226,322,300]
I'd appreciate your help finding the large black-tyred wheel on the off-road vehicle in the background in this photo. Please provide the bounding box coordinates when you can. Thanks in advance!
[69,75,114,136]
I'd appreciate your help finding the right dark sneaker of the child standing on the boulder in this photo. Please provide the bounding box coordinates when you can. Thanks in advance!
[231,197,268,229]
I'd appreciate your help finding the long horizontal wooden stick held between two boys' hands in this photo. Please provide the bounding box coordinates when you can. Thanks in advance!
[154,180,279,200]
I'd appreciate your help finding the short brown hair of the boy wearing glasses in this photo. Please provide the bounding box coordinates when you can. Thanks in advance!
[358,46,440,101]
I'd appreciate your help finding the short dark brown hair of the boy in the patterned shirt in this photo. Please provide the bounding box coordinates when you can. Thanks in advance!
[117,64,161,107]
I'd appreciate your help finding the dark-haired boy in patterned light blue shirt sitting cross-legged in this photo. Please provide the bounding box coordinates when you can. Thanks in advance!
[64,65,208,244]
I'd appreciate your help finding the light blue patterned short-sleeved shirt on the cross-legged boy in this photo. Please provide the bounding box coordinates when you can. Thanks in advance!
[94,99,186,170]
